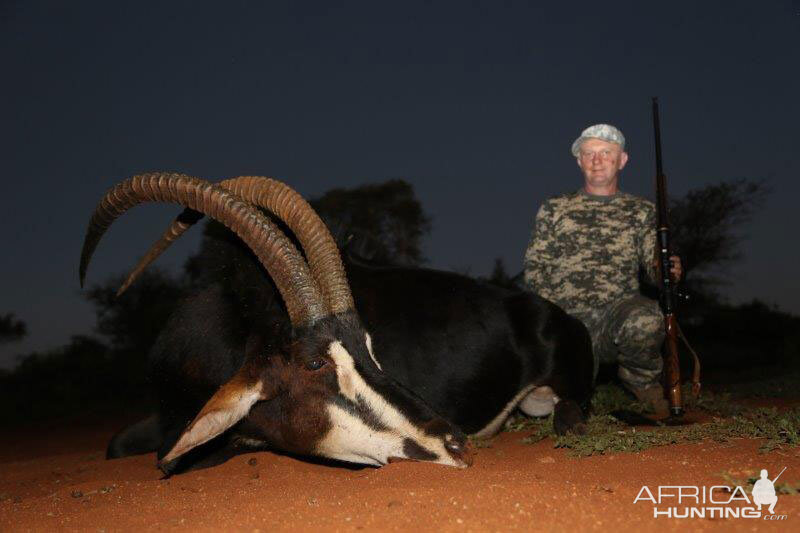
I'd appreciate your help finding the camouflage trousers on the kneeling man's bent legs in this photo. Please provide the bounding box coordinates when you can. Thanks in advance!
[575,296,665,389]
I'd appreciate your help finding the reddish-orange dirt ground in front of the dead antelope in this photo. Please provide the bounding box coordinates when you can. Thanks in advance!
[0,414,800,532]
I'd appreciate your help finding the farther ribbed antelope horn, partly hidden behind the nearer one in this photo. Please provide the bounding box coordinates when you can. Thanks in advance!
[117,176,354,313]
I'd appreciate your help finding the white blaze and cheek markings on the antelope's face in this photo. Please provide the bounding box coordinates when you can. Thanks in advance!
[318,341,462,466]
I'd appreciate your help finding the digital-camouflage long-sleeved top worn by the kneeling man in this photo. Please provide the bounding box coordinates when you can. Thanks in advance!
[525,189,656,315]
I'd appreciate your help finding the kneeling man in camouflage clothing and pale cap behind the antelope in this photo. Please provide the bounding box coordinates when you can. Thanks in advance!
[525,124,682,415]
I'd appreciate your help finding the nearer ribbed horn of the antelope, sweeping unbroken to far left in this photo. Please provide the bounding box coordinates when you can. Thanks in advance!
[80,173,328,326]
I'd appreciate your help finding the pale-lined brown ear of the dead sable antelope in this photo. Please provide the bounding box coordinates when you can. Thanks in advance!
[158,360,268,469]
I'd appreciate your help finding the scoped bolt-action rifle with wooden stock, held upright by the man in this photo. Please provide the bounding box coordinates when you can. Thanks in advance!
[653,97,700,417]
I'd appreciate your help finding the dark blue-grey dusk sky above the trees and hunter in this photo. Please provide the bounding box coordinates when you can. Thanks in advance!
[0,0,800,365]
